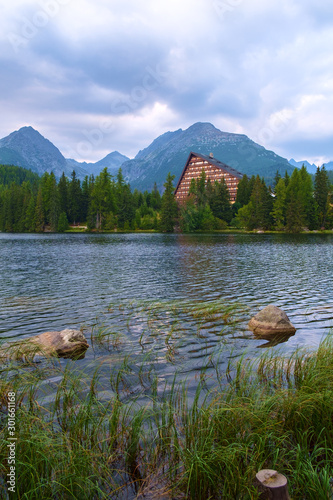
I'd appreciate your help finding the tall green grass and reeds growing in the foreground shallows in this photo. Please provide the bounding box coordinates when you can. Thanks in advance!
[0,303,333,500]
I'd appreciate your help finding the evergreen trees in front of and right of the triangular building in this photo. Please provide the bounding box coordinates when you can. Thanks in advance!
[174,166,333,233]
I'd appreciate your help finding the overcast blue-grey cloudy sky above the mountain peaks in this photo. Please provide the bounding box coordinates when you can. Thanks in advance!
[0,0,333,164]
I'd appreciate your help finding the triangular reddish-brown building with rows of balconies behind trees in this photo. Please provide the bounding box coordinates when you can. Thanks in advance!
[175,152,243,203]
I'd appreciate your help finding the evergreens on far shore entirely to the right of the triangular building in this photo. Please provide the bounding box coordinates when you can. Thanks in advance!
[235,165,333,233]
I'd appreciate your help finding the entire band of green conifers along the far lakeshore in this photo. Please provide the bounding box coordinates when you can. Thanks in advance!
[0,165,333,233]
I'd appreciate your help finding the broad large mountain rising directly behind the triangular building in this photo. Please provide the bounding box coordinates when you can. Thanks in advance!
[122,123,293,190]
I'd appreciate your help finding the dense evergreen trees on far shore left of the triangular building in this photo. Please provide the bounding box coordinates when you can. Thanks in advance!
[0,167,162,232]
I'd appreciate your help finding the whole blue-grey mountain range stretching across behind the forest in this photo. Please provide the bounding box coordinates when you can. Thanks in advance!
[0,123,333,191]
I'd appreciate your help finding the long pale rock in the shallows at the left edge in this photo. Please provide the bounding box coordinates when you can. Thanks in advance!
[0,329,89,359]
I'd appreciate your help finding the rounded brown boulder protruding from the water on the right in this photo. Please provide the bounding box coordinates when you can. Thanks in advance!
[248,305,296,336]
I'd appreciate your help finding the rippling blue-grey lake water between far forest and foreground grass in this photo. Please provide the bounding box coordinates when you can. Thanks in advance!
[0,233,333,396]
